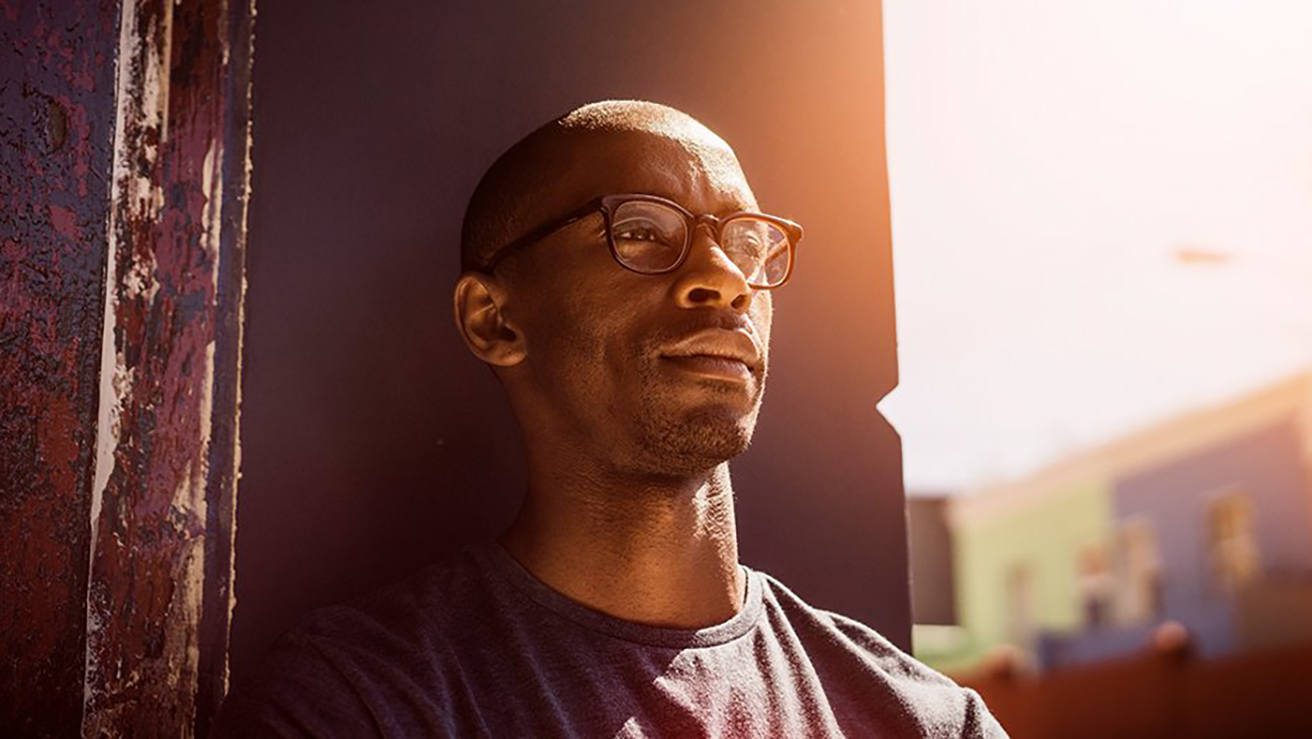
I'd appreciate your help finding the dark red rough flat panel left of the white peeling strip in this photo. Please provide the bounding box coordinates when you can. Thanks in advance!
[0,0,118,736]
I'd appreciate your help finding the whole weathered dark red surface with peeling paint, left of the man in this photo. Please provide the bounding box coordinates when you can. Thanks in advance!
[0,0,253,736]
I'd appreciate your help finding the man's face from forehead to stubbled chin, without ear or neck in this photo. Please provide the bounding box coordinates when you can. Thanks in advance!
[506,128,771,474]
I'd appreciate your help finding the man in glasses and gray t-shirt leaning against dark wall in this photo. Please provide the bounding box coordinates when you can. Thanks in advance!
[218,101,1005,736]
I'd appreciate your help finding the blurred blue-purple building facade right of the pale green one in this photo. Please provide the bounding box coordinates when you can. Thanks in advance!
[1036,375,1312,669]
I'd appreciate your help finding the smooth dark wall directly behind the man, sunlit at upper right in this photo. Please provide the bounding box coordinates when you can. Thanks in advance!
[232,0,909,679]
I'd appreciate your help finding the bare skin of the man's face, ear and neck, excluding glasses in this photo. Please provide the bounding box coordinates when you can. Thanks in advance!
[455,102,771,629]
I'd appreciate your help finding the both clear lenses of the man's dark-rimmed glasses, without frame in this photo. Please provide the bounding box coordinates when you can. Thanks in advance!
[610,201,791,286]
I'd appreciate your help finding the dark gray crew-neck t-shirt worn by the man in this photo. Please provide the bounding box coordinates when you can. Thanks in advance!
[220,542,1006,738]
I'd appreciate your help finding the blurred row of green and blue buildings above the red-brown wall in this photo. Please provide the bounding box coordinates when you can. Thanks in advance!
[909,371,1312,671]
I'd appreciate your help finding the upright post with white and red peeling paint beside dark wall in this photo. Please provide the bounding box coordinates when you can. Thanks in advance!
[83,0,248,736]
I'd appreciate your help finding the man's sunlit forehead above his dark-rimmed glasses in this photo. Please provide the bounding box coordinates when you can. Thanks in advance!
[535,130,757,213]
